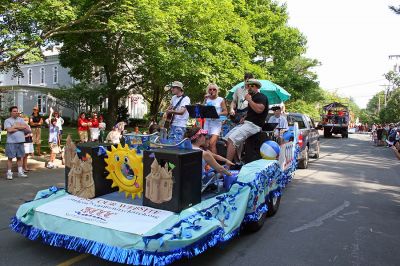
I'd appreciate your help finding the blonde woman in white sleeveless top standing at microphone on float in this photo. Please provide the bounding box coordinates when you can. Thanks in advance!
[204,83,228,153]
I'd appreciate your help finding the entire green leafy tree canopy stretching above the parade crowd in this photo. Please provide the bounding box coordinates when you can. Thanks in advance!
[0,0,328,124]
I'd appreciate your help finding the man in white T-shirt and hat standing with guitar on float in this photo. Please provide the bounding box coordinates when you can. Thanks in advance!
[166,81,190,141]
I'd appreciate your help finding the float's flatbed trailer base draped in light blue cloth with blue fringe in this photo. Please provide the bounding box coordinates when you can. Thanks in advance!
[10,136,299,265]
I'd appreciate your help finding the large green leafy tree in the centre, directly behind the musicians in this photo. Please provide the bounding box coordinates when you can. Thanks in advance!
[55,0,254,124]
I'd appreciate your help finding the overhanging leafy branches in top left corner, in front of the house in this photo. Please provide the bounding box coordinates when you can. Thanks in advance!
[0,0,115,72]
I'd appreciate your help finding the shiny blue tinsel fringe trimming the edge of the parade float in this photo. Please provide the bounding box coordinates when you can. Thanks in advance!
[10,149,299,265]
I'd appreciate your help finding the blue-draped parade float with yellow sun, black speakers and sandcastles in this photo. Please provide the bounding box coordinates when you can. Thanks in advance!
[10,125,299,265]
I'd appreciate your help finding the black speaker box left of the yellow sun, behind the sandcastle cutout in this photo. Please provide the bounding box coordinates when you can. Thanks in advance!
[65,142,118,197]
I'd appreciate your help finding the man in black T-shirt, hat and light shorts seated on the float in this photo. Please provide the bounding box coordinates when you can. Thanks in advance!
[225,79,268,165]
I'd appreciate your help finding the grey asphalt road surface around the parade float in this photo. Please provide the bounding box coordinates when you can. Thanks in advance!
[0,135,400,265]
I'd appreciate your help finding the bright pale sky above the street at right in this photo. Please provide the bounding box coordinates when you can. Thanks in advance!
[279,0,400,108]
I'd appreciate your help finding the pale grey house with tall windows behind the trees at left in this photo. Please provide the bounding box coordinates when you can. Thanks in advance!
[0,54,147,119]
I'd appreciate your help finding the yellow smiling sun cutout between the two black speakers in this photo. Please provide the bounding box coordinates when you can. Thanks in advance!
[104,144,143,199]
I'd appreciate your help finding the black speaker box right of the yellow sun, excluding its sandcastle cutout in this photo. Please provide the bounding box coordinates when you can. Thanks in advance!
[143,149,202,212]
